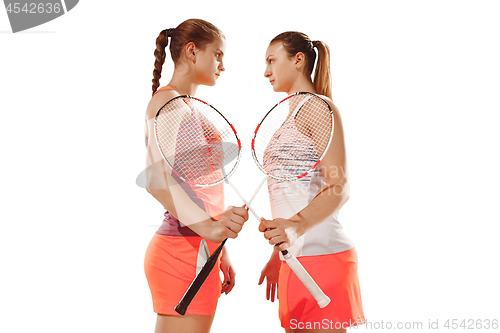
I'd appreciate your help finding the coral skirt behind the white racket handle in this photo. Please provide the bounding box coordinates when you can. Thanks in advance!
[278,248,365,329]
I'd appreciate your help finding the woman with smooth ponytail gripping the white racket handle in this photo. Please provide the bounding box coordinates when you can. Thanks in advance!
[259,32,365,333]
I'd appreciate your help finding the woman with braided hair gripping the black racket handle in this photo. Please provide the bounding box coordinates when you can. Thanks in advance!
[144,19,248,333]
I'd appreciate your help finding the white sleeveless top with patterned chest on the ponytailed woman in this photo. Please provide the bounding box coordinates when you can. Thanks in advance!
[264,110,354,259]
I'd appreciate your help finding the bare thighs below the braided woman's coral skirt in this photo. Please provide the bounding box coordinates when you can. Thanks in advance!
[155,315,214,333]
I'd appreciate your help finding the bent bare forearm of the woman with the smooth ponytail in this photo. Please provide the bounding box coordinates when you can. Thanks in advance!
[290,180,349,237]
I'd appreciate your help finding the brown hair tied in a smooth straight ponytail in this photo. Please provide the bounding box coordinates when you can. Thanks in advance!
[269,31,332,98]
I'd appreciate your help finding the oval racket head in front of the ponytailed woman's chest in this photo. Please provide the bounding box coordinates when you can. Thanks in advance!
[251,92,334,181]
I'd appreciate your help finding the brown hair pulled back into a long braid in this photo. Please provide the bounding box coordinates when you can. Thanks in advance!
[152,19,225,94]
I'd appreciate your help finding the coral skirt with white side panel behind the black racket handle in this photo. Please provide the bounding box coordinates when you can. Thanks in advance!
[144,234,222,315]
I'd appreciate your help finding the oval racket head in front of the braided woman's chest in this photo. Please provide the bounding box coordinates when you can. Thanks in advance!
[154,95,241,187]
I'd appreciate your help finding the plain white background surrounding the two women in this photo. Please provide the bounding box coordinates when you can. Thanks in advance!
[0,0,500,333]
